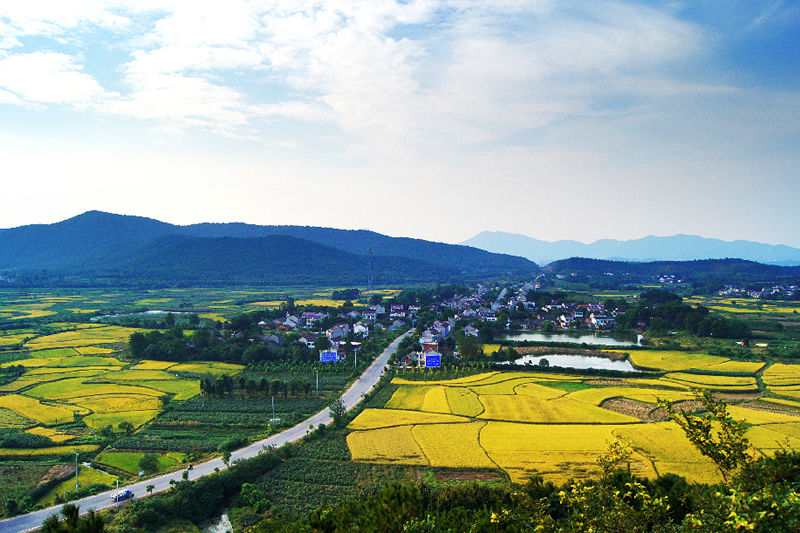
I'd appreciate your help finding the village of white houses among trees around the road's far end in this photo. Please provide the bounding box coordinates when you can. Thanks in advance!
[237,282,620,368]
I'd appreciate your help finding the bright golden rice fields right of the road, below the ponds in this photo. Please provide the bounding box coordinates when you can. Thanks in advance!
[347,364,800,482]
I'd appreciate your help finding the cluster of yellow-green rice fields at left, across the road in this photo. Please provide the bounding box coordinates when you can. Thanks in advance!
[0,323,225,450]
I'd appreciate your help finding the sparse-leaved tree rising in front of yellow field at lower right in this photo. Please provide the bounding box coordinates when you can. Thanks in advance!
[659,391,752,482]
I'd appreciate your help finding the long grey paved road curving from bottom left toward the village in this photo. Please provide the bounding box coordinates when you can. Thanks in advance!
[0,331,411,533]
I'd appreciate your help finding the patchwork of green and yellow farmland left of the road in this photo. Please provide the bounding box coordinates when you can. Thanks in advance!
[0,288,388,508]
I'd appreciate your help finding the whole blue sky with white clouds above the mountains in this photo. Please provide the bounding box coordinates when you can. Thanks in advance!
[0,0,800,246]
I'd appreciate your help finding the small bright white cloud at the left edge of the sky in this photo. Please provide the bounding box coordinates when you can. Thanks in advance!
[0,52,103,104]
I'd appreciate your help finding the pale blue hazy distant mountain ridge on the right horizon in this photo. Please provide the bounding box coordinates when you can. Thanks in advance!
[461,231,800,266]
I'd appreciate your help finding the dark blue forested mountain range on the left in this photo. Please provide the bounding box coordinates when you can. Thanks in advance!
[0,211,539,286]
